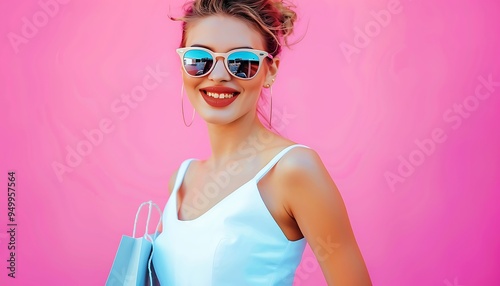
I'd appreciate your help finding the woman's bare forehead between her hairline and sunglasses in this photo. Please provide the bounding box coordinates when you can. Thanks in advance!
[186,15,265,52]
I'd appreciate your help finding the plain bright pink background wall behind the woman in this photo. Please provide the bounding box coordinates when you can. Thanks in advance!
[0,0,500,286]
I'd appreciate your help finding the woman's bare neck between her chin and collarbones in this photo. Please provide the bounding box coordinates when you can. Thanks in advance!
[208,114,269,167]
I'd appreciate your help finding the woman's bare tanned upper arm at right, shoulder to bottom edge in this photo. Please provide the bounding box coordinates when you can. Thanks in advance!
[280,148,371,286]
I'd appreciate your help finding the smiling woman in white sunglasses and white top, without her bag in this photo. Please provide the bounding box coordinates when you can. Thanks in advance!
[153,0,371,286]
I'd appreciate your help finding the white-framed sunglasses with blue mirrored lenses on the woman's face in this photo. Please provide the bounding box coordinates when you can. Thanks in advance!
[177,47,273,80]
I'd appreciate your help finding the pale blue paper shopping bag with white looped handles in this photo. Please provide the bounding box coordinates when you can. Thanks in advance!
[106,201,161,286]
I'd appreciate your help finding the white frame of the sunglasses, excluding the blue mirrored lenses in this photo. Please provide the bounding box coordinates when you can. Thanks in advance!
[176,47,274,80]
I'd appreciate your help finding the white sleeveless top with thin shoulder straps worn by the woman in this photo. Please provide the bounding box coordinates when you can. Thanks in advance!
[153,145,308,286]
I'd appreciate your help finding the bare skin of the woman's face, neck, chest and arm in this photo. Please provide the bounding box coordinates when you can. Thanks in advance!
[164,15,371,286]
